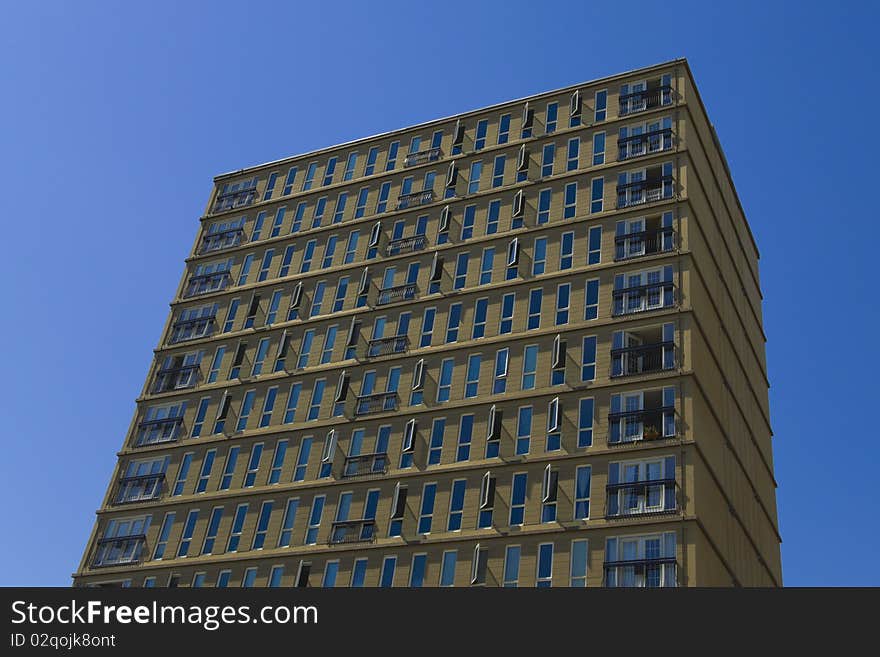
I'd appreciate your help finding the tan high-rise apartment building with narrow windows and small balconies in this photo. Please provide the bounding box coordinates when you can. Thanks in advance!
[74,60,782,587]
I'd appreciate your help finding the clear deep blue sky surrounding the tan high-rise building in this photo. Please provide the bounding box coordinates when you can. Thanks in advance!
[0,0,880,586]
